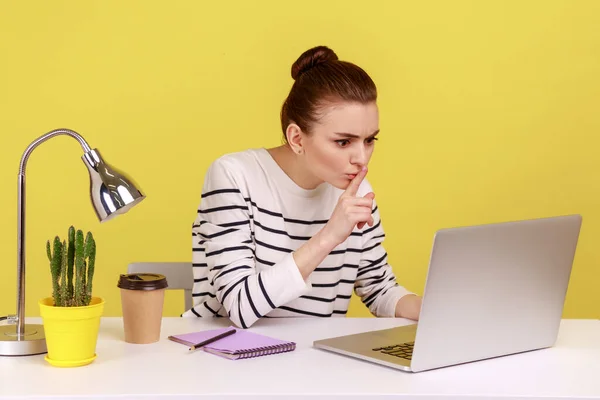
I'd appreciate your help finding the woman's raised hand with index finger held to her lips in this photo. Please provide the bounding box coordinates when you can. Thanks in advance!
[323,167,375,246]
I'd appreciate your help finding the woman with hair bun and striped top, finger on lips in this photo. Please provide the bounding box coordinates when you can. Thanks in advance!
[183,46,421,328]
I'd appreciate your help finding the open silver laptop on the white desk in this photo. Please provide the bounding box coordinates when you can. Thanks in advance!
[313,215,582,372]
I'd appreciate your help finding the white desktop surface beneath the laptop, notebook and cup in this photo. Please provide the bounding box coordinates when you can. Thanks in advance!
[0,318,600,400]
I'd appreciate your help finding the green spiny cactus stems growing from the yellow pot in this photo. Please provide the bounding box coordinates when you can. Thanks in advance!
[46,226,96,307]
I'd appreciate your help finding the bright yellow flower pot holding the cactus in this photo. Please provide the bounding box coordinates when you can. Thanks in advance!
[38,297,104,367]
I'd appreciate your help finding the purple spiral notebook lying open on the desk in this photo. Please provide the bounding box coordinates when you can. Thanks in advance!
[168,326,296,360]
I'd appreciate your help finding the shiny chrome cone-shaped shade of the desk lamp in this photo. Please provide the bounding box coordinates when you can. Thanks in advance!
[81,149,146,222]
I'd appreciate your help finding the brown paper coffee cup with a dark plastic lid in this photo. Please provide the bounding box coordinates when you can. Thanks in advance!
[117,273,168,344]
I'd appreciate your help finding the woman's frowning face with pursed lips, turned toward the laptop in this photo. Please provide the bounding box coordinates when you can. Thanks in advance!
[302,102,379,190]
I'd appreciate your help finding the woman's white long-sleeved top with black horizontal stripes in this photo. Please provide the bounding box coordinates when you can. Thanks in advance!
[182,148,409,328]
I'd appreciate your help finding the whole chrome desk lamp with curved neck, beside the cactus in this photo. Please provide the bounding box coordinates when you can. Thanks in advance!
[0,129,145,356]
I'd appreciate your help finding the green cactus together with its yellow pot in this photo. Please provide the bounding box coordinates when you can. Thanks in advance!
[39,226,104,367]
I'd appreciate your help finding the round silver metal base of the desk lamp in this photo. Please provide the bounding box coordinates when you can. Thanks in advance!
[0,324,48,356]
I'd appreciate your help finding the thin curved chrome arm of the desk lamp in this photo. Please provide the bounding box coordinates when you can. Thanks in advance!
[16,129,91,340]
